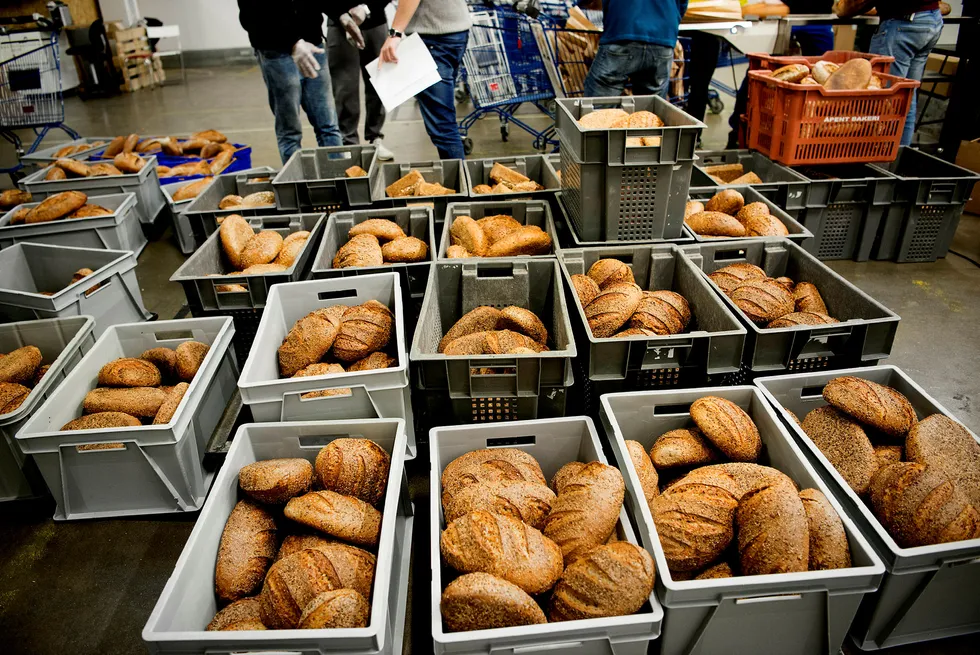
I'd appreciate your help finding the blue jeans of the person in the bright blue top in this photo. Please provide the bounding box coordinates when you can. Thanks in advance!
[585,42,674,98]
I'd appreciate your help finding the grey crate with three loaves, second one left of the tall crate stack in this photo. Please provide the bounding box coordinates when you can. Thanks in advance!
[311,207,436,316]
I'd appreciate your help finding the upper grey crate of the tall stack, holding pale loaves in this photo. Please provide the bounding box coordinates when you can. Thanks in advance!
[555,96,707,165]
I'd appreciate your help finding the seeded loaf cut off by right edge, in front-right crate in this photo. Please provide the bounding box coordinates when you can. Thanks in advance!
[905,414,980,508]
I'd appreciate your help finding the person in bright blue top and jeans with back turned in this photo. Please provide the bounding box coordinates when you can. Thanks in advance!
[585,0,687,98]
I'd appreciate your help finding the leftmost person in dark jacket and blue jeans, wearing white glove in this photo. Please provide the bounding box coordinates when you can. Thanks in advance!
[238,0,341,164]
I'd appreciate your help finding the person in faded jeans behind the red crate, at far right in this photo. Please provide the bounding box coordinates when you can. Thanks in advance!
[834,0,943,146]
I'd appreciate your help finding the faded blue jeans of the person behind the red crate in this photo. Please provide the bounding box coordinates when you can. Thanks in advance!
[870,9,943,146]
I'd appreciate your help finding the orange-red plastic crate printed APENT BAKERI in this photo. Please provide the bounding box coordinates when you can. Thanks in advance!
[748,70,919,166]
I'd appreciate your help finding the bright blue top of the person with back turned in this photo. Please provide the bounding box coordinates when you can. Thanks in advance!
[599,0,687,48]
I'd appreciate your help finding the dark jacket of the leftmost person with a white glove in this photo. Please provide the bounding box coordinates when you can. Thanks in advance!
[238,0,333,53]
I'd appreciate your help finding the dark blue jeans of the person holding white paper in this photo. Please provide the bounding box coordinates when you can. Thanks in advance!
[415,31,470,159]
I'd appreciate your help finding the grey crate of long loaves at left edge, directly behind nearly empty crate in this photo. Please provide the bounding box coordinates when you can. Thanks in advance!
[0,193,146,257]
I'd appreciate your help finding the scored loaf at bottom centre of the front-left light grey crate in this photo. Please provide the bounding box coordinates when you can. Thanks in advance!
[259,548,341,630]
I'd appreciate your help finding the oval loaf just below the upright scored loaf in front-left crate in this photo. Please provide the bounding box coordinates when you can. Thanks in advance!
[284,491,381,546]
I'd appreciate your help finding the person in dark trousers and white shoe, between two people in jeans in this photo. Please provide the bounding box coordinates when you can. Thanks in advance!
[327,0,395,161]
